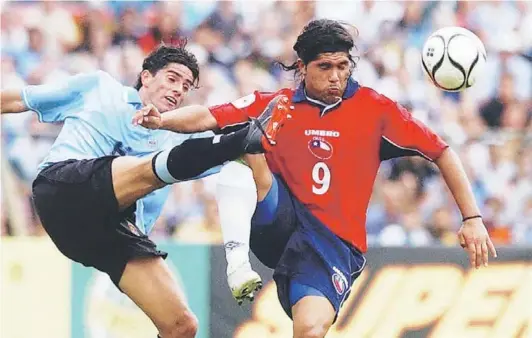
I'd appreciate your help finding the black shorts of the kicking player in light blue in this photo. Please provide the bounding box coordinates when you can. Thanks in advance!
[33,156,167,286]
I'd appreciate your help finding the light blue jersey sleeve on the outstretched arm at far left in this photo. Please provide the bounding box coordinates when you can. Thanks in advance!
[22,72,100,122]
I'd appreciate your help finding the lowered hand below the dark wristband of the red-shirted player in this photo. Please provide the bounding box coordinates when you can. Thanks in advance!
[458,218,497,269]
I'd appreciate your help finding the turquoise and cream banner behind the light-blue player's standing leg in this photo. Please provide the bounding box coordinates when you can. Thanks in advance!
[71,243,210,338]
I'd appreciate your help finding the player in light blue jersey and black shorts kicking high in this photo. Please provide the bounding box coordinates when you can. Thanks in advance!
[1,46,285,338]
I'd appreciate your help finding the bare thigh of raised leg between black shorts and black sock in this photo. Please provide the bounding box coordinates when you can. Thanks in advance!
[111,156,164,210]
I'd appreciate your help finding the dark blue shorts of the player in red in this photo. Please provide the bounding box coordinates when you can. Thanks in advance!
[251,176,366,318]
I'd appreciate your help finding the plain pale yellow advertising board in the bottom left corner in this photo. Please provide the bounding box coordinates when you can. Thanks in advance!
[0,237,71,338]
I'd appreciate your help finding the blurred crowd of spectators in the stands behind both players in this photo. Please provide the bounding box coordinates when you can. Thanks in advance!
[1,0,532,246]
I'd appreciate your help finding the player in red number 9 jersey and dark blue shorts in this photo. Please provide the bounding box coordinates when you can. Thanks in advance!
[134,20,496,338]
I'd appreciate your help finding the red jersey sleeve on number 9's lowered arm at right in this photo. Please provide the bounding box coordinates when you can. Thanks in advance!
[377,94,448,161]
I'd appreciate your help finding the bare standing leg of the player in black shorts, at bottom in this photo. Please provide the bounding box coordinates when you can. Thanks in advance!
[118,257,197,337]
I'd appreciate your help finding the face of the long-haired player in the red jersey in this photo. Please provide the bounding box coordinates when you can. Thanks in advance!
[300,52,351,104]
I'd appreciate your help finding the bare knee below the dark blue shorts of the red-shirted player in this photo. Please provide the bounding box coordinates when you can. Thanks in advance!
[292,295,336,338]
